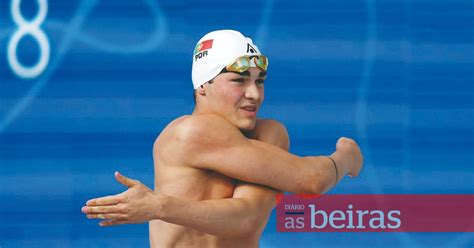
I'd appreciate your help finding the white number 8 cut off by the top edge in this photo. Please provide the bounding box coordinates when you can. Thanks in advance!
[8,0,49,78]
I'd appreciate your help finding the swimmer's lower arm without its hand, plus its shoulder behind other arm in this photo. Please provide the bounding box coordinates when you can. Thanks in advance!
[154,120,289,237]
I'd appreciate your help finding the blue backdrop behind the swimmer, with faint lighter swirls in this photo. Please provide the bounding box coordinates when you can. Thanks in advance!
[0,0,474,248]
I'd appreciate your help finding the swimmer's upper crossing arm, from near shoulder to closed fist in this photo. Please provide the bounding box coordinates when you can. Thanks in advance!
[172,115,362,194]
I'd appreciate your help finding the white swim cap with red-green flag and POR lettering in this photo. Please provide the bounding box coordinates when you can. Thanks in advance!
[192,30,261,89]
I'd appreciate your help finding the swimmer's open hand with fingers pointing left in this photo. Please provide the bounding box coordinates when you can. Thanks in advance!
[81,172,160,226]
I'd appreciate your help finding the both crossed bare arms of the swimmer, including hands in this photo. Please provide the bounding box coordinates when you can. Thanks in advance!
[83,116,362,236]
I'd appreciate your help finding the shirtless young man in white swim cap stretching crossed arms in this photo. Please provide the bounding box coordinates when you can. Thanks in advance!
[83,30,362,247]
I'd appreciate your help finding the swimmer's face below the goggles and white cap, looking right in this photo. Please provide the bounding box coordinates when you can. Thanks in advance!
[206,67,266,131]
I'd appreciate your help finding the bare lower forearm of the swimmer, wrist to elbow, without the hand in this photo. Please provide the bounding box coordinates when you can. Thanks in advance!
[155,184,275,238]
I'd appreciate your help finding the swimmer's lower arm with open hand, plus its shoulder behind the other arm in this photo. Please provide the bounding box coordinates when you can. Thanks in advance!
[83,120,289,237]
